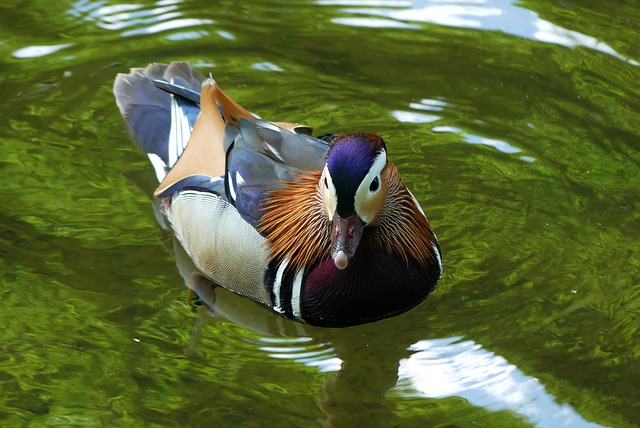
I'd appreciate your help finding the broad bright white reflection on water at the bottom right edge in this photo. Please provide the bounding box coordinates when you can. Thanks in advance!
[393,337,600,427]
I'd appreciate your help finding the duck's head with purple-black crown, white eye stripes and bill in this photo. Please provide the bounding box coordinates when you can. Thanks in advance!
[318,133,387,270]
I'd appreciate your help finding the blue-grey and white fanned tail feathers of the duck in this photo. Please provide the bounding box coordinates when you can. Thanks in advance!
[113,62,205,182]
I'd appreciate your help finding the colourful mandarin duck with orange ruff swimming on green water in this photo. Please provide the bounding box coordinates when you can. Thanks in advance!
[113,62,442,327]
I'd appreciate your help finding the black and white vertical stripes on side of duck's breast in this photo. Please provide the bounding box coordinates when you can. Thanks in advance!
[265,259,304,321]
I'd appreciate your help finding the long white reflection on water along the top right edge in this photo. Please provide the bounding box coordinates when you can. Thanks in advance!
[318,0,639,65]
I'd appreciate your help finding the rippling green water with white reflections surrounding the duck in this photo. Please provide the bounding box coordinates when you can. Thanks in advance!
[0,0,640,427]
